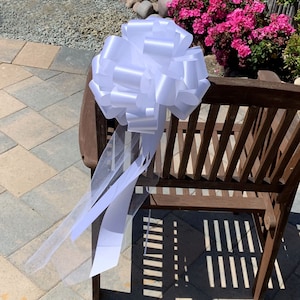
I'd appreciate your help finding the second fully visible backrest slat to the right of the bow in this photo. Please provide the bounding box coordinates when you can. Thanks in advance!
[209,105,239,180]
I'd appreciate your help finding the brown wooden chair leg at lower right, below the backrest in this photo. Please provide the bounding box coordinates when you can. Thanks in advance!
[253,204,290,300]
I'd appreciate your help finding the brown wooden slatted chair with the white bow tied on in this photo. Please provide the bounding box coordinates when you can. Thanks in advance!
[80,73,300,299]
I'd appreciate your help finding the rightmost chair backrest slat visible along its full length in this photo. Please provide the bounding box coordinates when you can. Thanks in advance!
[255,109,297,183]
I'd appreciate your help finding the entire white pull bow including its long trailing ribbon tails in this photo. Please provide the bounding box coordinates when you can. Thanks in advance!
[27,17,209,284]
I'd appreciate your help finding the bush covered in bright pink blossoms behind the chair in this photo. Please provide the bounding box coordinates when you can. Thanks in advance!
[168,0,294,75]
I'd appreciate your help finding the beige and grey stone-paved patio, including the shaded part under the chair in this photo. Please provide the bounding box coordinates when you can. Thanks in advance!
[0,39,300,300]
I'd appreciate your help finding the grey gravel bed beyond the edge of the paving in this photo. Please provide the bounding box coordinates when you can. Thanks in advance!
[0,0,137,52]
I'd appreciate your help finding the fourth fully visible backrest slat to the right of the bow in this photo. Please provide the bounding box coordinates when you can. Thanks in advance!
[240,107,277,182]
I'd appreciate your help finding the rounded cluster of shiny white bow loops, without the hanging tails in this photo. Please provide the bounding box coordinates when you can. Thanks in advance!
[90,17,209,133]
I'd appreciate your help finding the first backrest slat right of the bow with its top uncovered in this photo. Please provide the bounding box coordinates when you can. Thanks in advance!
[194,104,221,180]
